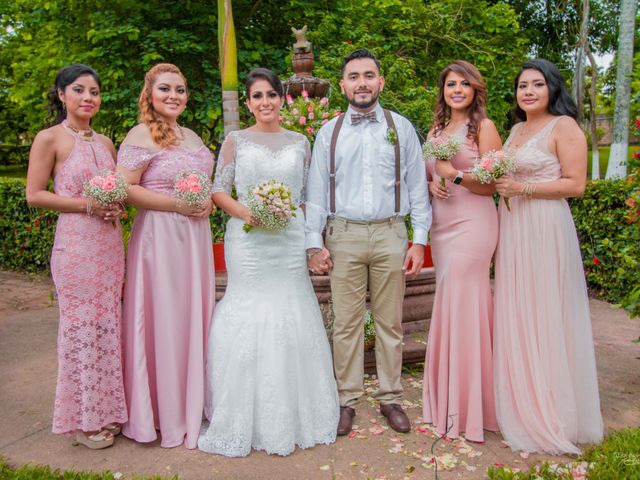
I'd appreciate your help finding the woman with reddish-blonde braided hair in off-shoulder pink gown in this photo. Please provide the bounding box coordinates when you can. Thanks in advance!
[118,64,215,448]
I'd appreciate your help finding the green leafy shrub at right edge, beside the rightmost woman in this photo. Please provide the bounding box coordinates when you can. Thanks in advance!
[571,175,640,317]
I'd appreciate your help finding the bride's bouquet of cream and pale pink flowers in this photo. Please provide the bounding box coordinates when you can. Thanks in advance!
[242,180,296,232]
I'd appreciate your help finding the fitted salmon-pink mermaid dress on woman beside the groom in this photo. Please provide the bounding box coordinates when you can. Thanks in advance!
[422,127,498,442]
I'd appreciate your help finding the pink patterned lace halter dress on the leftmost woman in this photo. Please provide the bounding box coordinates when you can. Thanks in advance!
[51,122,127,433]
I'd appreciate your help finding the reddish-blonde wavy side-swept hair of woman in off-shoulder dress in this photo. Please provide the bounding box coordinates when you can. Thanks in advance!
[138,63,189,148]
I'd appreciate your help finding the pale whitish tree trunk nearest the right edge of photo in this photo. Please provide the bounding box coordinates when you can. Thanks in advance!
[607,0,637,178]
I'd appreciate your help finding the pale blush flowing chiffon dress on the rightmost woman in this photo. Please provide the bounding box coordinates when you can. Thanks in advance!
[494,117,602,454]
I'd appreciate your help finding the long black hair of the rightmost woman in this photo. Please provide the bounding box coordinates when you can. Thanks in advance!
[513,58,578,121]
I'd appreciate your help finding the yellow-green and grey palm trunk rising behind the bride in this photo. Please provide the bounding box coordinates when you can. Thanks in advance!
[218,0,240,137]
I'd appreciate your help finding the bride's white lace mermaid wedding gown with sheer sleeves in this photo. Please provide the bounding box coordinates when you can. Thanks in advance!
[198,130,339,457]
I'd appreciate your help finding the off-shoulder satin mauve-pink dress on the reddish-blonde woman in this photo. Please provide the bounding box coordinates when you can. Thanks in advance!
[118,145,215,448]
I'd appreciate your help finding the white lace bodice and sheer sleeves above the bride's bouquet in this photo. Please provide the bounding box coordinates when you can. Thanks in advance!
[213,130,311,205]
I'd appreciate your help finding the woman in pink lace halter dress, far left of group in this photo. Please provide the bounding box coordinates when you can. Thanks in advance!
[26,64,127,449]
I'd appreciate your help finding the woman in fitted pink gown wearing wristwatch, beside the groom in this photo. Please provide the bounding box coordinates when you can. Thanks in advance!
[423,60,501,442]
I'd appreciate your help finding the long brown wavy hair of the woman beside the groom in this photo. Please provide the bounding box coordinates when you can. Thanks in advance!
[433,60,487,144]
